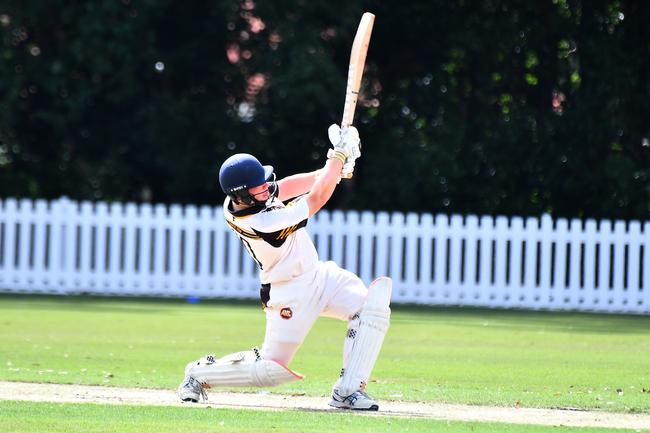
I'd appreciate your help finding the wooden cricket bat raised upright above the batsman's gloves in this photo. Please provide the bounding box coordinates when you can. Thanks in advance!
[341,12,375,179]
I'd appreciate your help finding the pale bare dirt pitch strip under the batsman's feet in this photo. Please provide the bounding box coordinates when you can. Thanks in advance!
[0,381,650,431]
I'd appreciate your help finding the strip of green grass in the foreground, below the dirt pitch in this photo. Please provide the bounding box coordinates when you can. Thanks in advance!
[0,401,633,433]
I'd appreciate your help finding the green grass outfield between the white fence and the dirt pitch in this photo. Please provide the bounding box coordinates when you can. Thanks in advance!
[0,295,650,431]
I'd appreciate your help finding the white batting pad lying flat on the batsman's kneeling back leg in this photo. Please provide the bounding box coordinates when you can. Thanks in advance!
[185,350,303,387]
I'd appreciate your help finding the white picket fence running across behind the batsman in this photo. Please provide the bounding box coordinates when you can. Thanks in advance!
[0,199,650,313]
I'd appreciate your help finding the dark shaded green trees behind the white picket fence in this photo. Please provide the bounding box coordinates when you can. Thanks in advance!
[0,0,650,219]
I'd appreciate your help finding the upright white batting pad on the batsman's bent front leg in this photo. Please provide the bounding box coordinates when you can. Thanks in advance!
[337,277,393,396]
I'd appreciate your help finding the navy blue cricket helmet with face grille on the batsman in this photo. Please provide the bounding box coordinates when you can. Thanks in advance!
[219,153,277,205]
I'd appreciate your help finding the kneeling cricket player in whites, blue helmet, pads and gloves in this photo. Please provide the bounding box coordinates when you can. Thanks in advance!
[178,125,392,411]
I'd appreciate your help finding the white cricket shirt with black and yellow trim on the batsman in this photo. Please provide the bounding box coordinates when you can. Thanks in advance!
[223,197,318,284]
